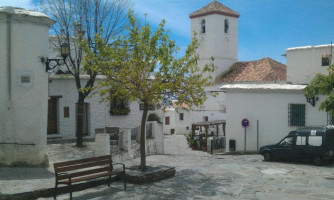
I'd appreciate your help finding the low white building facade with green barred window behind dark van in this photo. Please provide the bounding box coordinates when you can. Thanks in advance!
[222,84,329,152]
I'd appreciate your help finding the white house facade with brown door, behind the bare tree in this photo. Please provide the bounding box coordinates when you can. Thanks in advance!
[48,75,163,139]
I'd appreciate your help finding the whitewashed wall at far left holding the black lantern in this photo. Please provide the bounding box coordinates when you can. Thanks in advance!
[0,7,54,166]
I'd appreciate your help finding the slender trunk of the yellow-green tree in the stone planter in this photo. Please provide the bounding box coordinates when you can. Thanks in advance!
[140,102,148,172]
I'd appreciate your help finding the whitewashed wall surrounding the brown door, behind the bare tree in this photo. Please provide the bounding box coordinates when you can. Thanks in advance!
[48,75,163,138]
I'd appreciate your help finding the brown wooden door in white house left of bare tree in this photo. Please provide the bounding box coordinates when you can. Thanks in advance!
[47,97,58,134]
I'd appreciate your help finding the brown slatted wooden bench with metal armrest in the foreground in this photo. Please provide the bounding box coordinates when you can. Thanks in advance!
[53,155,126,199]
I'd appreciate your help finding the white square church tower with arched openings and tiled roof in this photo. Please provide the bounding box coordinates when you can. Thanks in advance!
[189,0,240,78]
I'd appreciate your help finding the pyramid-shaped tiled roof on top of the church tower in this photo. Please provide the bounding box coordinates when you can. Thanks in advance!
[189,0,240,18]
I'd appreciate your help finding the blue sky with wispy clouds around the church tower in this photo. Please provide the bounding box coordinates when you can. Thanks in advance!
[0,0,334,63]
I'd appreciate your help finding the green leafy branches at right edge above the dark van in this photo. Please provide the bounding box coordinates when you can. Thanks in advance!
[304,65,334,116]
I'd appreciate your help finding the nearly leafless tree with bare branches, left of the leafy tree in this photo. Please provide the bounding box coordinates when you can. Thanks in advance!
[41,0,129,147]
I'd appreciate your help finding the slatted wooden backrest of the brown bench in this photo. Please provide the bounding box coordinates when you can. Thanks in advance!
[53,155,113,180]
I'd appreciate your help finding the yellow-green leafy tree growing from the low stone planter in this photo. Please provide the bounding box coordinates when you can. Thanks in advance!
[85,11,214,171]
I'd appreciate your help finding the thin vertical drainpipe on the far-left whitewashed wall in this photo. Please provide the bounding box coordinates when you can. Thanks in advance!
[7,14,12,104]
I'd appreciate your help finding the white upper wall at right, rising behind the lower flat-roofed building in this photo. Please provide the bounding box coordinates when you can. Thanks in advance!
[286,45,334,84]
